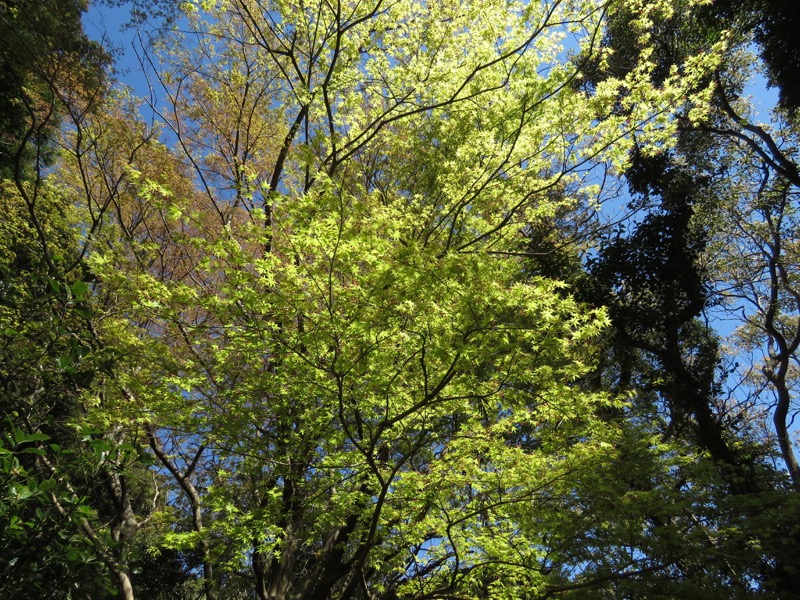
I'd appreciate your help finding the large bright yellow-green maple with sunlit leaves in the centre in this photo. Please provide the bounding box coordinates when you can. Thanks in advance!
[73,1,736,598]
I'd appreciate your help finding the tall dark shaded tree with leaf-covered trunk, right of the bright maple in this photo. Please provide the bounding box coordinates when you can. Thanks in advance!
[568,2,800,597]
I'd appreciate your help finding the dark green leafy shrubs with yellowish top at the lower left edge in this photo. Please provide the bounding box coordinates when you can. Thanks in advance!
[0,177,108,598]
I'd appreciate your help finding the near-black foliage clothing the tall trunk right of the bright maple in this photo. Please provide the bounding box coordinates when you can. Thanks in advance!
[564,1,800,584]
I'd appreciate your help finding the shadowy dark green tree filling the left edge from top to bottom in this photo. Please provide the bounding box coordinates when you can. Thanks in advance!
[0,1,173,598]
